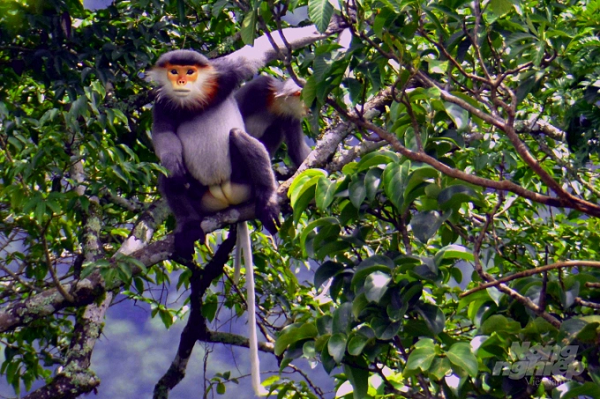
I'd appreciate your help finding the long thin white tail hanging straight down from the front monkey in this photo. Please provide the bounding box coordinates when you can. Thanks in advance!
[234,222,267,396]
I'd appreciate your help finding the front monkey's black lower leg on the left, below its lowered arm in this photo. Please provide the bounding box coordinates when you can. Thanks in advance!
[160,176,204,261]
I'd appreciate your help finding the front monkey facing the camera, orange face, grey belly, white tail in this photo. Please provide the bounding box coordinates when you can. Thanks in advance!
[149,50,279,395]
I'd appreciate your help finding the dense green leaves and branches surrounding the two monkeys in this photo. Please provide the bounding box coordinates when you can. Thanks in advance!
[0,0,600,399]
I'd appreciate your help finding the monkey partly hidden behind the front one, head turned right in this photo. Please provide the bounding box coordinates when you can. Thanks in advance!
[235,75,311,167]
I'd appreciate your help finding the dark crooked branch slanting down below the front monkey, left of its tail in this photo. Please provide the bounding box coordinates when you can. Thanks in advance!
[153,231,236,399]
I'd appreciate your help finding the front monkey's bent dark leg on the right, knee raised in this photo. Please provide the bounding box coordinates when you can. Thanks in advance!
[229,129,279,234]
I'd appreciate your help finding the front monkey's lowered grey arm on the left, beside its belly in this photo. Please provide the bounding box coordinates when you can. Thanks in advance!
[152,104,186,180]
